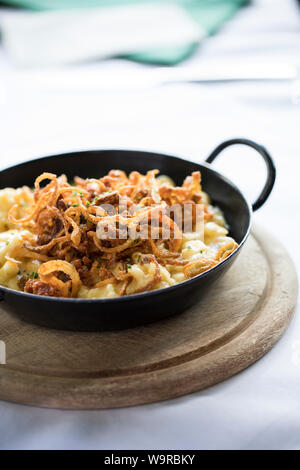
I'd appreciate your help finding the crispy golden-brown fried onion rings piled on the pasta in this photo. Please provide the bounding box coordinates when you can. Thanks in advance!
[8,170,236,297]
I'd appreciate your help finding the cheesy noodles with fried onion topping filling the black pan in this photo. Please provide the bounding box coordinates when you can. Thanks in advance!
[0,170,238,298]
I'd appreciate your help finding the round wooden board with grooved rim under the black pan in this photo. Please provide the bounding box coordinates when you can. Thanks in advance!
[0,227,298,409]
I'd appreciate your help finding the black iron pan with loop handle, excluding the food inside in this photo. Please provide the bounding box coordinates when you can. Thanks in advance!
[0,139,275,331]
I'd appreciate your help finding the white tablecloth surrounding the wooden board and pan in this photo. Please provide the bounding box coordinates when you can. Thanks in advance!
[0,0,300,449]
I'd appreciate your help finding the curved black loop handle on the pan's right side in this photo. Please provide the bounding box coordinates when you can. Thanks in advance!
[205,138,276,211]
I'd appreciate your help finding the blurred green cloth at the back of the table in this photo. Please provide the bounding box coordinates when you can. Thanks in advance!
[0,0,250,65]
